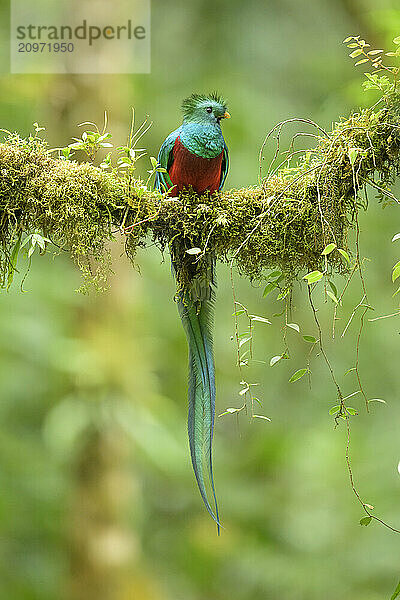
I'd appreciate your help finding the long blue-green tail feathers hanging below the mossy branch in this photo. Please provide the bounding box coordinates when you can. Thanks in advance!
[177,268,220,534]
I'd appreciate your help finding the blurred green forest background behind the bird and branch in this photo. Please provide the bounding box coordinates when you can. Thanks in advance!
[0,0,400,600]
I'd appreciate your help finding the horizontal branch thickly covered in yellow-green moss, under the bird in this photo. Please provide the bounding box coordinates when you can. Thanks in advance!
[0,95,400,285]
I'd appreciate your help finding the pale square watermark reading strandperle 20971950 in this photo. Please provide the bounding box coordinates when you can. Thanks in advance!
[10,0,150,74]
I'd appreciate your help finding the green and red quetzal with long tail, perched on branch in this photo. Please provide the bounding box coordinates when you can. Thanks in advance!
[156,93,230,533]
